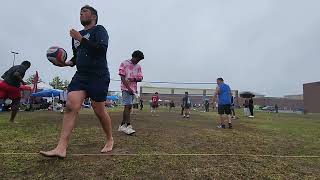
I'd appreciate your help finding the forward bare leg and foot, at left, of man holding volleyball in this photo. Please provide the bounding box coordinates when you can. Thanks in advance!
[40,91,86,157]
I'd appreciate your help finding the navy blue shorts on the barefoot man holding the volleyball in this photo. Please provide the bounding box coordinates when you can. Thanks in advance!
[68,73,110,102]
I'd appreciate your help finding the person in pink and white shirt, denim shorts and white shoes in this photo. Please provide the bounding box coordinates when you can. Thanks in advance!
[118,50,144,135]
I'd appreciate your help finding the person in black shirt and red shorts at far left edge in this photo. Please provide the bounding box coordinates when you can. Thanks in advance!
[0,61,31,122]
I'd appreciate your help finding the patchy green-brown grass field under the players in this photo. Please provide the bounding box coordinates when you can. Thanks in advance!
[0,109,320,179]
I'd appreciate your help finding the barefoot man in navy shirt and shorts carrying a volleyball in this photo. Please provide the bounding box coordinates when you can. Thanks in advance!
[40,5,113,158]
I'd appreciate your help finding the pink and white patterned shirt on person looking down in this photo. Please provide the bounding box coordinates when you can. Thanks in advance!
[119,60,143,92]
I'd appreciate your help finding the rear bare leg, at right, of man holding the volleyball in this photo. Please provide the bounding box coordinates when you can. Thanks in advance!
[92,101,113,153]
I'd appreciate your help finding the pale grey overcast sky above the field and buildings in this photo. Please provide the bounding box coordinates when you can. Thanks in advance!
[0,0,320,96]
